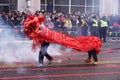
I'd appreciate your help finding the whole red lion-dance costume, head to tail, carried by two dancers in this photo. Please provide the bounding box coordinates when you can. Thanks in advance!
[23,15,102,54]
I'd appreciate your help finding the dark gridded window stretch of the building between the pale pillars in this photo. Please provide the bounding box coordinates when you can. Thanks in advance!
[40,0,100,13]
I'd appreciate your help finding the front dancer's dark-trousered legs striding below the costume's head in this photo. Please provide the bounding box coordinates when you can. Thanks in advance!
[39,41,53,67]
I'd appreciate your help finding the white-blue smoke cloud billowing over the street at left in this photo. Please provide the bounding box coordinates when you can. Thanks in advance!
[0,25,61,63]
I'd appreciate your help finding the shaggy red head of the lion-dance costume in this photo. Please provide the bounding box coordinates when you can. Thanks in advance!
[23,15,45,36]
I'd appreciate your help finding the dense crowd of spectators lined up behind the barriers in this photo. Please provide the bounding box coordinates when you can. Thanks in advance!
[0,10,120,37]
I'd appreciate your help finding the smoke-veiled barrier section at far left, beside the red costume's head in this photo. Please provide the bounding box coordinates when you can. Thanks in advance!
[0,25,27,40]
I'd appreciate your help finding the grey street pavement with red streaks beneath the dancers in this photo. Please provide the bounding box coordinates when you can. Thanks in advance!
[0,41,120,80]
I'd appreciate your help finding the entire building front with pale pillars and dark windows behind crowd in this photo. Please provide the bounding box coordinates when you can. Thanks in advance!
[0,0,120,15]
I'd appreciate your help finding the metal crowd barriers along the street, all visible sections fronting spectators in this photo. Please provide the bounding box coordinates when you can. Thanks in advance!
[0,25,120,40]
